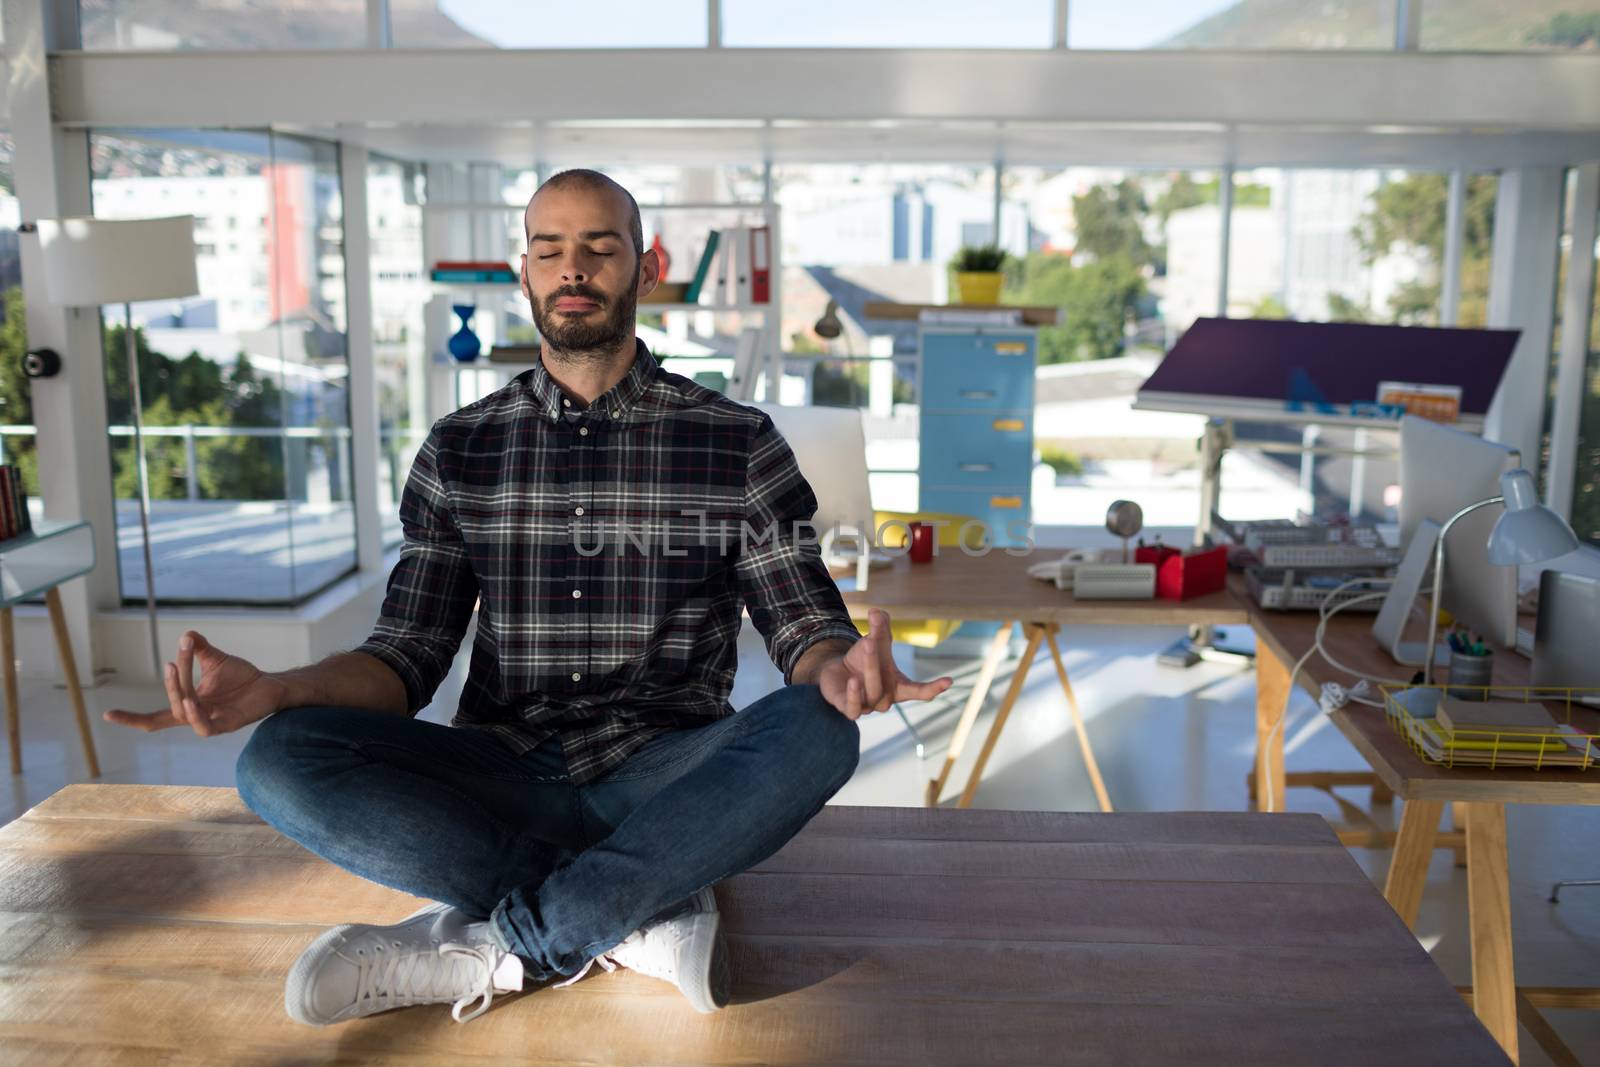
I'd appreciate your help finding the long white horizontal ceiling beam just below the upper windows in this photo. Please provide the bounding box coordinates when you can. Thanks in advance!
[51,48,1600,131]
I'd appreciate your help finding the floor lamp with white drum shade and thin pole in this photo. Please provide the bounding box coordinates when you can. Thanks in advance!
[38,214,200,680]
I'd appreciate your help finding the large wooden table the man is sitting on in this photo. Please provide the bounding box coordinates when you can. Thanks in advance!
[0,785,1506,1067]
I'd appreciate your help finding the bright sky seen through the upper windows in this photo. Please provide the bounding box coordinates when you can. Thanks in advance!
[441,0,1238,48]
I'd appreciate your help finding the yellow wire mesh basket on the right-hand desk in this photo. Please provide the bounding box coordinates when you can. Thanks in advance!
[1379,683,1600,771]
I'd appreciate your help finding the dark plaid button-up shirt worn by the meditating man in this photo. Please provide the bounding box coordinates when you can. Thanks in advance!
[355,341,861,782]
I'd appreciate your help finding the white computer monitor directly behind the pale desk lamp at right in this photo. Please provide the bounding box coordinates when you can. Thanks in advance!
[1400,414,1522,648]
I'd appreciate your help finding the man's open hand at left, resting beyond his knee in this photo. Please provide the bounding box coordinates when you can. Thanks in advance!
[104,630,288,737]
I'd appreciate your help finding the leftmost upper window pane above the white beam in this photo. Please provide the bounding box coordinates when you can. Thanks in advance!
[78,0,366,51]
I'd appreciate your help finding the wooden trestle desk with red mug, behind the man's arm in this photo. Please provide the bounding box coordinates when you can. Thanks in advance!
[843,547,1250,811]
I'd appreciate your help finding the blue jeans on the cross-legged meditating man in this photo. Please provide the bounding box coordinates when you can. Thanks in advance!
[238,685,861,981]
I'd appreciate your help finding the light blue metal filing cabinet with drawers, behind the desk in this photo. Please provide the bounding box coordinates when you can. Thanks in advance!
[917,325,1038,640]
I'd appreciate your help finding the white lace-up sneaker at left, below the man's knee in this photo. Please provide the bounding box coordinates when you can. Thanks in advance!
[283,904,522,1025]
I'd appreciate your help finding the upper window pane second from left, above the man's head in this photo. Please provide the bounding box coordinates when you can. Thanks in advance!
[389,0,706,48]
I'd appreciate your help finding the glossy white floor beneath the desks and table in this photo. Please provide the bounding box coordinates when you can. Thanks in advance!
[0,627,1600,1065]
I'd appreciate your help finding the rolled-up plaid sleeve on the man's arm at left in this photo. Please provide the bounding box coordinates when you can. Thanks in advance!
[354,427,478,715]
